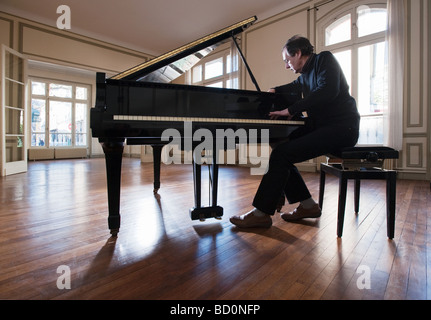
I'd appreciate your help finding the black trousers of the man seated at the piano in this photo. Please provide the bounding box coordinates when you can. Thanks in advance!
[253,125,359,215]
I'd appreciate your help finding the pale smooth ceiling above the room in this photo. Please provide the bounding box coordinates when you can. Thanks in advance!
[0,0,307,55]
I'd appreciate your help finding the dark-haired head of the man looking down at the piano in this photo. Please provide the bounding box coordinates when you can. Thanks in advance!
[282,35,314,73]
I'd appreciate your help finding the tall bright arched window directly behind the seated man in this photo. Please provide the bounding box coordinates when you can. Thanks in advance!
[323,5,388,145]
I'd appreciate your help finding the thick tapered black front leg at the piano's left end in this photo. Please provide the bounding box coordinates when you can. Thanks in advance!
[101,141,124,237]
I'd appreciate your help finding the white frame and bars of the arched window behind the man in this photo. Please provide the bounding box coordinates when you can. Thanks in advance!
[317,1,387,145]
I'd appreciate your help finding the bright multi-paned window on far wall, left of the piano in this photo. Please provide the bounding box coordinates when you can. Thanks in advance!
[30,79,90,148]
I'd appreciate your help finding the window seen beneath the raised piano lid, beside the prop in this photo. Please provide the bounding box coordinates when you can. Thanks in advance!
[190,50,238,89]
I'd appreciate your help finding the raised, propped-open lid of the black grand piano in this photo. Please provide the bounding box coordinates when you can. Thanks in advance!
[111,16,257,83]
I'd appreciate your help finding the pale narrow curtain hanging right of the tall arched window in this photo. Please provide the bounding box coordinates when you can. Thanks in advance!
[384,0,405,150]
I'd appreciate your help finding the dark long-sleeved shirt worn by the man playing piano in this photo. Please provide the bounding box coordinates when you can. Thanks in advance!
[275,51,360,129]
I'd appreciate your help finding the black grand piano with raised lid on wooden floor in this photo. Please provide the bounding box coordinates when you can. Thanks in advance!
[90,17,303,236]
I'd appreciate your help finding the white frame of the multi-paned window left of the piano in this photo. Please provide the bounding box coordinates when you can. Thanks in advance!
[28,77,92,149]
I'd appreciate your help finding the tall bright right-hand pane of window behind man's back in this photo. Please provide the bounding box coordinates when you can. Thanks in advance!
[357,42,388,115]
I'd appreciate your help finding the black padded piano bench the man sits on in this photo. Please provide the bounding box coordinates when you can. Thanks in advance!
[319,147,399,239]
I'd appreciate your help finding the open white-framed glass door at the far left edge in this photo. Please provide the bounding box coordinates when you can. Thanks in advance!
[1,45,27,176]
